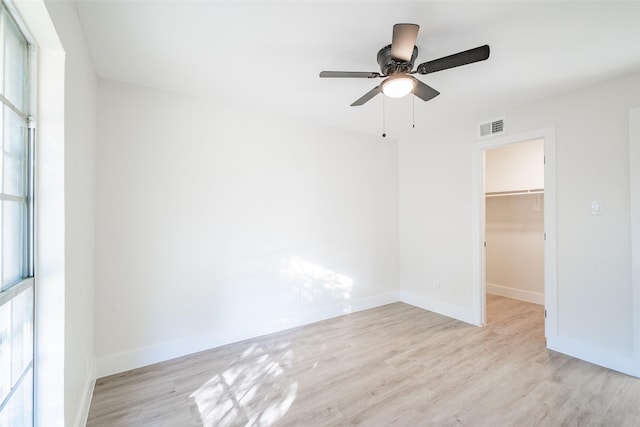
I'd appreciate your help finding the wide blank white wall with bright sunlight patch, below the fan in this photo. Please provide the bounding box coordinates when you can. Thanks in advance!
[96,81,398,376]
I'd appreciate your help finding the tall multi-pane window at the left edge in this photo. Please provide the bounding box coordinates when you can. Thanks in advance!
[0,4,34,426]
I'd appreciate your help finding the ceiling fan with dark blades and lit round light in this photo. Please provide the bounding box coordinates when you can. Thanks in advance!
[320,24,489,107]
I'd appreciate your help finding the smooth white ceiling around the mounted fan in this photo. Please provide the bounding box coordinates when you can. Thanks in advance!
[76,0,640,135]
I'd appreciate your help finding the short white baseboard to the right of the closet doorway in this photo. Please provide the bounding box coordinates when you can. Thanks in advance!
[547,337,640,377]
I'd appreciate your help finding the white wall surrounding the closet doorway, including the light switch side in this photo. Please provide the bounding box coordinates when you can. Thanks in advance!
[399,74,640,375]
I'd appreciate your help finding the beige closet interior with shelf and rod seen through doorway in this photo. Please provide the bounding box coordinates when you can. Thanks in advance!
[485,139,544,304]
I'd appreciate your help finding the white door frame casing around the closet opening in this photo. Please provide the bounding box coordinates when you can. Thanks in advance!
[471,127,557,341]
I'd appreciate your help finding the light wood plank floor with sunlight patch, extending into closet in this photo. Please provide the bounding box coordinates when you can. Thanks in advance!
[88,296,640,427]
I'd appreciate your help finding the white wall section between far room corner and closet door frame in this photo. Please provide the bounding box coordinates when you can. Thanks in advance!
[398,120,477,323]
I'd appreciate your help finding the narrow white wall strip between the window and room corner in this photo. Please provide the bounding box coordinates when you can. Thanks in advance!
[47,1,97,426]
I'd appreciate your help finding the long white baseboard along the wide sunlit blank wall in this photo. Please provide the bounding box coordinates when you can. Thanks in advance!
[96,292,399,378]
